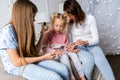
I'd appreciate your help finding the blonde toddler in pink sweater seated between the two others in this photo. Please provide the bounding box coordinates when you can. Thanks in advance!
[43,13,86,80]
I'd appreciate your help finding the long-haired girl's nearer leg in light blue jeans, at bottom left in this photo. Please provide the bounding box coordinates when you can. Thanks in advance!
[14,64,63,80]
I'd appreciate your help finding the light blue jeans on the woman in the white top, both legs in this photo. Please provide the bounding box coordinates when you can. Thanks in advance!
[78,45,115,80]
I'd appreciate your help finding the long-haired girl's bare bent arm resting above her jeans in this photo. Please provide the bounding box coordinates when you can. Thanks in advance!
[7,49,55,66]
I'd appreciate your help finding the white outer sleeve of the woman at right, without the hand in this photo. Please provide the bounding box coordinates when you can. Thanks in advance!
[88,15,99,46]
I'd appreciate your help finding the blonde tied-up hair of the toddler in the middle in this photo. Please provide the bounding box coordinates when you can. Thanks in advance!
[51,13,70,32]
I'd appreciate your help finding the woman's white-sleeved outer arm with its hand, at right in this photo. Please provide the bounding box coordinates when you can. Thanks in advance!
[75,15,99,46]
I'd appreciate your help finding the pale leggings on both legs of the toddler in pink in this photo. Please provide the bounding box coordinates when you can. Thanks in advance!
[56,52,84,77]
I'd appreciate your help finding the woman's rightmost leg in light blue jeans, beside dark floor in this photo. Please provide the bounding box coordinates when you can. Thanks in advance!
[87,46,115,80]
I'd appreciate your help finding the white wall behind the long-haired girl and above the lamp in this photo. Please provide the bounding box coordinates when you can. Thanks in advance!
[0,0,64,38]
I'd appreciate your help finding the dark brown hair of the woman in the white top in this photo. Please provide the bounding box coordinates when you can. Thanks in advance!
[63,0,86,24]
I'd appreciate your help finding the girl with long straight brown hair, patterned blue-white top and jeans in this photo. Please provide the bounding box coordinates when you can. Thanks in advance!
[0,0,69,80]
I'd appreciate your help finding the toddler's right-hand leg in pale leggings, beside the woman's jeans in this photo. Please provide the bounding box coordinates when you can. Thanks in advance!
[68,52,84,77]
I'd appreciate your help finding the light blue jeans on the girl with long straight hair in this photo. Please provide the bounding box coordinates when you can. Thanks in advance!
[14,60,69,80]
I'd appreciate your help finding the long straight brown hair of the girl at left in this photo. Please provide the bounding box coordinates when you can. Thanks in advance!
[10,0,38,57]
